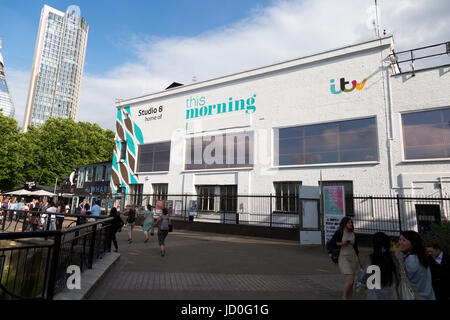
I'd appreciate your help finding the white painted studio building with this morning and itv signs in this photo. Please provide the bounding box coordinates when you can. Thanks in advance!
[112,36,450,230]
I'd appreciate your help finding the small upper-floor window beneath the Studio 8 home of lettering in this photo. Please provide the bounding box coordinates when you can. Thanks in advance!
[137,142,170,172]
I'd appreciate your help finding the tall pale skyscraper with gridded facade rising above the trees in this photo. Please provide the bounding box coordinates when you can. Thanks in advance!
[23,5,89,131]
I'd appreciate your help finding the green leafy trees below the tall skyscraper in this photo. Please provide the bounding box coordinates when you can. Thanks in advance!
[0,114,115,191]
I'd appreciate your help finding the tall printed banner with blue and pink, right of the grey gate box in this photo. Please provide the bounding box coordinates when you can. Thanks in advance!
[322,186,345,242]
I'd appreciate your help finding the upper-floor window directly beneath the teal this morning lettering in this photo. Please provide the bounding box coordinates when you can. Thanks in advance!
[185,132,253,170]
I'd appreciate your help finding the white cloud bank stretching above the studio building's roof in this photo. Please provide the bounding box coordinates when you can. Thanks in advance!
[10,0,450,130]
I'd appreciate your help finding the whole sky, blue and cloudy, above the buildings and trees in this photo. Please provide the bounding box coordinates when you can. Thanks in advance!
[0,0,450,130]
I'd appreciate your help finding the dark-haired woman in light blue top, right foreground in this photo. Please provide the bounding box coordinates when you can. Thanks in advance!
[394,231,436,300]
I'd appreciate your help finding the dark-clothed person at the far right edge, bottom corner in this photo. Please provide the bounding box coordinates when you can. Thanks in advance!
[425,241,450,301]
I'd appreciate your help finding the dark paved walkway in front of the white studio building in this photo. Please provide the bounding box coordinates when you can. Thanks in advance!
[90,228,365,300]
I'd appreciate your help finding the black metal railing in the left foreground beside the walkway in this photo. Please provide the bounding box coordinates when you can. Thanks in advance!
[0,215,113,300]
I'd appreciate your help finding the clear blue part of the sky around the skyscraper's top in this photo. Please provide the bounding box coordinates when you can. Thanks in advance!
[0,0,273,74]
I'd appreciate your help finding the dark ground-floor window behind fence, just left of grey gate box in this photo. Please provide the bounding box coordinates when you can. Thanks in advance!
[273,181,302,214]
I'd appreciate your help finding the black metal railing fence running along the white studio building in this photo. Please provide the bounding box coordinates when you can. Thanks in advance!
[123,194,450,235]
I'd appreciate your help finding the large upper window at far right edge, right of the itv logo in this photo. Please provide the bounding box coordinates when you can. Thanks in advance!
[402,108,450,160]
